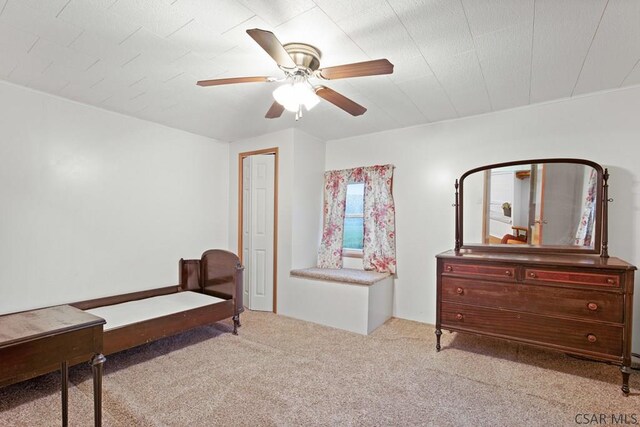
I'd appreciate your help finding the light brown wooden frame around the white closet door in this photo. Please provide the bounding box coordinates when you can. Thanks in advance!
[238,147,278,313]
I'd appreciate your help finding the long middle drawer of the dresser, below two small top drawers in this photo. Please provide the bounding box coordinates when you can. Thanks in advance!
[442,277,624,323]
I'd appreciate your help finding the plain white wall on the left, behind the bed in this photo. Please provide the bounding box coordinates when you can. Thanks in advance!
[0,82,229,313]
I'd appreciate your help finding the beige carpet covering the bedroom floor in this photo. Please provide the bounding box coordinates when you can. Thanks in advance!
[0,312,640,426]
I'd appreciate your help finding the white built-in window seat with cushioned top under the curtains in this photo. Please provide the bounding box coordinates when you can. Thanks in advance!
[290,268,393,335]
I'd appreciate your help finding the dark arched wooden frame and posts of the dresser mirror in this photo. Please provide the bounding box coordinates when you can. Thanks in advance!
[454,158,609,258]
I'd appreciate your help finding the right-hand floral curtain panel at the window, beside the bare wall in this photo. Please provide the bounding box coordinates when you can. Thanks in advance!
[363,165,396,274]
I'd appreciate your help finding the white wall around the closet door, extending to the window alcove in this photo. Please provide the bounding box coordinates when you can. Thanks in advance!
[228,129,325,315]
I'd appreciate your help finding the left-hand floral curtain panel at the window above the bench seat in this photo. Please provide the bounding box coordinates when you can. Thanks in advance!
[318,169,351,268]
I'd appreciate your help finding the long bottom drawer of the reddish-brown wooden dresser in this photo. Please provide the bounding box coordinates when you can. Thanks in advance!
[441,302,623,360]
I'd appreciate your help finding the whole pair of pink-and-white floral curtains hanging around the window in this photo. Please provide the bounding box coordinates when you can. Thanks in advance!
[318,165,396,273]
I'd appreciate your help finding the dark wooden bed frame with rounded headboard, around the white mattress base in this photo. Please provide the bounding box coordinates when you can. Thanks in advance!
[71,249,244,354]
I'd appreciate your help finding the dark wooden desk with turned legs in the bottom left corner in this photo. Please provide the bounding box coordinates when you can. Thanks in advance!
[0,305,105,426]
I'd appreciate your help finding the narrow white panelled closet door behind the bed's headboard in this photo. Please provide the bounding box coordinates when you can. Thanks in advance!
[242,154,275,311]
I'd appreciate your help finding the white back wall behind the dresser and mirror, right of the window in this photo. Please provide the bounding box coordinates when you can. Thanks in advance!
[326,87,640,351]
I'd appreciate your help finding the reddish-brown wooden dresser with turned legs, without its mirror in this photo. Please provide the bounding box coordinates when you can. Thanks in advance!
[436,249,636,394]
